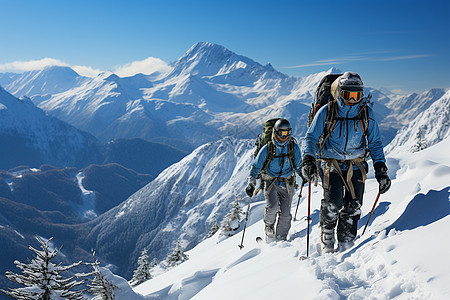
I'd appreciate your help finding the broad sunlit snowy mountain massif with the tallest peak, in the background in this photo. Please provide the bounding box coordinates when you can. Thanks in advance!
[0,42,397,151]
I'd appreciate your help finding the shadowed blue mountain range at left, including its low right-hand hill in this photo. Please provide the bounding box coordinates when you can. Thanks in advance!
[0,87,186,172]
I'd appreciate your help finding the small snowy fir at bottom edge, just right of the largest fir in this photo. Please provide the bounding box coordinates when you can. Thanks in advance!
[81,260,117,300]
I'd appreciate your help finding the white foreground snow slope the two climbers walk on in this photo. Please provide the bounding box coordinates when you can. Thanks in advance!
[134,138,450,299]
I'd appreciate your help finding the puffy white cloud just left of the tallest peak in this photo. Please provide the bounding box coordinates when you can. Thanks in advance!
[113,57,171,77]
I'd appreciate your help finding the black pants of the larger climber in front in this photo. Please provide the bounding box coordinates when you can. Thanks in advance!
[320,169,364,242]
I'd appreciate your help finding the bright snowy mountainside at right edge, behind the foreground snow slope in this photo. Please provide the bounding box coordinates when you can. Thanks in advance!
[385,90,450,154]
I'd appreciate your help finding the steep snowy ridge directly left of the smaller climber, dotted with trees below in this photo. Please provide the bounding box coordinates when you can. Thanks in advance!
[83,137,253,277]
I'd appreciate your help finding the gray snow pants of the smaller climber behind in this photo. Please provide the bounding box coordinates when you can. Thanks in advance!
[264,182,295,240]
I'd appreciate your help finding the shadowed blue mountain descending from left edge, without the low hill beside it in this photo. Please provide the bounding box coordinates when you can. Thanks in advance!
[0,87,96,169]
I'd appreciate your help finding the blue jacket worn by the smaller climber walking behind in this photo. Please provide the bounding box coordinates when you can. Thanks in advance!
[250,139,302,186]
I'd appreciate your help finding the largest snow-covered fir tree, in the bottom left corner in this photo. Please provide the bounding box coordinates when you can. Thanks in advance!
[0,236,86,300]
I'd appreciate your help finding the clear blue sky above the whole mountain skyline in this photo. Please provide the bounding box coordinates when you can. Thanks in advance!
[0,0,450,92]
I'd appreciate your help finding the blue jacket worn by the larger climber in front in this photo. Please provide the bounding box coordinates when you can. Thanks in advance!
[302,101,385,168]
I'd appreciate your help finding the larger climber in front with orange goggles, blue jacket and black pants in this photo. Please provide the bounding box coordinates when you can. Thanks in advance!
[302,72,391,253]
